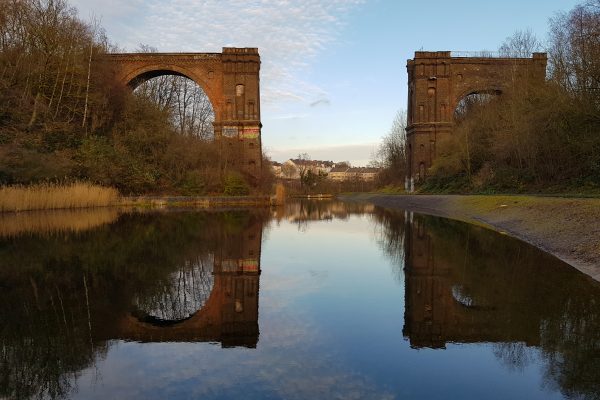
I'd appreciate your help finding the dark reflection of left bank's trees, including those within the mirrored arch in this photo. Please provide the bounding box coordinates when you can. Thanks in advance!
[0,211,265,399]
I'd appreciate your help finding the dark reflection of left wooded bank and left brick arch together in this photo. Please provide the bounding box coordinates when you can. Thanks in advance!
[0,211,265,398]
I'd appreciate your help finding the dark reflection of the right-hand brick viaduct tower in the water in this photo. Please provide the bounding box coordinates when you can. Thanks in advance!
[402,214,539,348]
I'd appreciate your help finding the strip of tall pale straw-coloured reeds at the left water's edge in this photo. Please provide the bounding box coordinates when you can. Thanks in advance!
[0,182,119,212]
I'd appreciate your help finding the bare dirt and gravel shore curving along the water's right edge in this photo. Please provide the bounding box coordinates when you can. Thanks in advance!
[344,194,600,281]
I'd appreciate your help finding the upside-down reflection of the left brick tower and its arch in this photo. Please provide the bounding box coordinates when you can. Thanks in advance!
[111,219,262,347]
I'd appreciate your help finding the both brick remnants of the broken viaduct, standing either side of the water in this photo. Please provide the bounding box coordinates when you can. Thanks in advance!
[105,47,547,188]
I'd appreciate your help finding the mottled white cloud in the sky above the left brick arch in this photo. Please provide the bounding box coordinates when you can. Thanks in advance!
[68,0,363,104]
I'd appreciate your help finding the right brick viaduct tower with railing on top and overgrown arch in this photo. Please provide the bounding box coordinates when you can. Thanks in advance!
[406,51,547,188]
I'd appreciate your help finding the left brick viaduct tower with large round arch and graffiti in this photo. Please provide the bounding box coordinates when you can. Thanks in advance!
[105,47,262,179]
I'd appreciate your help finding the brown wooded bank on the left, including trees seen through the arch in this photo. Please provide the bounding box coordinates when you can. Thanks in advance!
[0,0,270,195]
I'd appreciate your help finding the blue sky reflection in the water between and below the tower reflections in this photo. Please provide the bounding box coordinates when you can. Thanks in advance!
[73,216,560,399]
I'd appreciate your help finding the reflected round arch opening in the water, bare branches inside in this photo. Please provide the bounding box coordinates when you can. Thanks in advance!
[132,256,214,326]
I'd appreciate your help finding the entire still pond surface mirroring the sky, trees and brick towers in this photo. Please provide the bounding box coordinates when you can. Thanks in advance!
[0,201,600,399]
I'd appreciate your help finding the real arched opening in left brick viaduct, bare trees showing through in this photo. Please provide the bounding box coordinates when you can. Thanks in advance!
[129,70,215,140]
